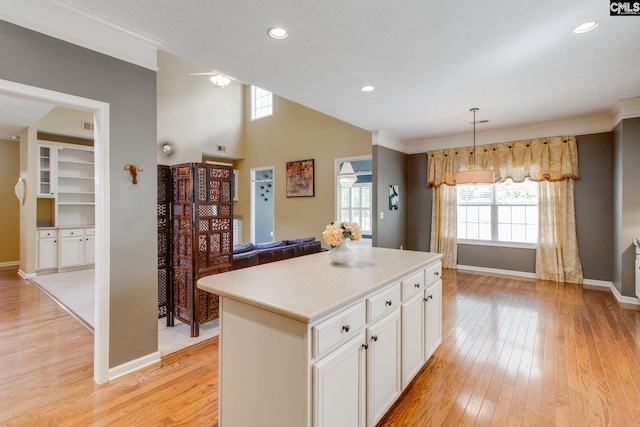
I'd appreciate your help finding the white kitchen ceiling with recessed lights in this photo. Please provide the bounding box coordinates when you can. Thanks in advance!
[1,0,640,150]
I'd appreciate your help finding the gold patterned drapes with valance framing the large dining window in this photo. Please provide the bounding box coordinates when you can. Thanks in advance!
[427,136,582,283]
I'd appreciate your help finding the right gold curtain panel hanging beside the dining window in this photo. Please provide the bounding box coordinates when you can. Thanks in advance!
[536,179,583,283]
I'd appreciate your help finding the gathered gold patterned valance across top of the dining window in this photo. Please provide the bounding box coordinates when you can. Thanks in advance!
[427,136,580,187]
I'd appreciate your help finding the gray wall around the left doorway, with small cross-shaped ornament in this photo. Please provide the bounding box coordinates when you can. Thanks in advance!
[0,21,158,367]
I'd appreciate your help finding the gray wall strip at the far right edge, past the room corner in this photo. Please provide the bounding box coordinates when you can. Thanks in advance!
[613,118,640,296]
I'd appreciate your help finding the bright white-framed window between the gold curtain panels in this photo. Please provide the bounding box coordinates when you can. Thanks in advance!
[456,180,538,244]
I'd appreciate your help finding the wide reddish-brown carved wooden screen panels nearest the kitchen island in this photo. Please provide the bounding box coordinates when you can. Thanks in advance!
[171,163,233,336]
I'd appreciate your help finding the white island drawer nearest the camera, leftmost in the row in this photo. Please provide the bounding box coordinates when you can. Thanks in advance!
[312,302,366,358]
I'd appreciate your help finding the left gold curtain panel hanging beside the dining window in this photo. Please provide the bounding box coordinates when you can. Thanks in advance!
[431,185,458,268]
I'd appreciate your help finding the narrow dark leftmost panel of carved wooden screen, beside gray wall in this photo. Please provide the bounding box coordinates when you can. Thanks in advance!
[157,165,173,326]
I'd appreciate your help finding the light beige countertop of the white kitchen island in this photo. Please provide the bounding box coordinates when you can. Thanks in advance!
[198,247,442,323]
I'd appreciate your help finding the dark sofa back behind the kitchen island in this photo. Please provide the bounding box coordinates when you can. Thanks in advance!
[233,237,323,270]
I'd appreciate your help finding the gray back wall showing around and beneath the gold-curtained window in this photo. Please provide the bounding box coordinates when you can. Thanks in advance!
[406,133,616,281]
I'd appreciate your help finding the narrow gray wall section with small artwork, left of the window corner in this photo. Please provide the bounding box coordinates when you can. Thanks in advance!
[372,145,410,249]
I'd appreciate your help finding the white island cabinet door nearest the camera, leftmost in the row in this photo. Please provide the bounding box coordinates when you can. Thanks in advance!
[313,333,365,427]
